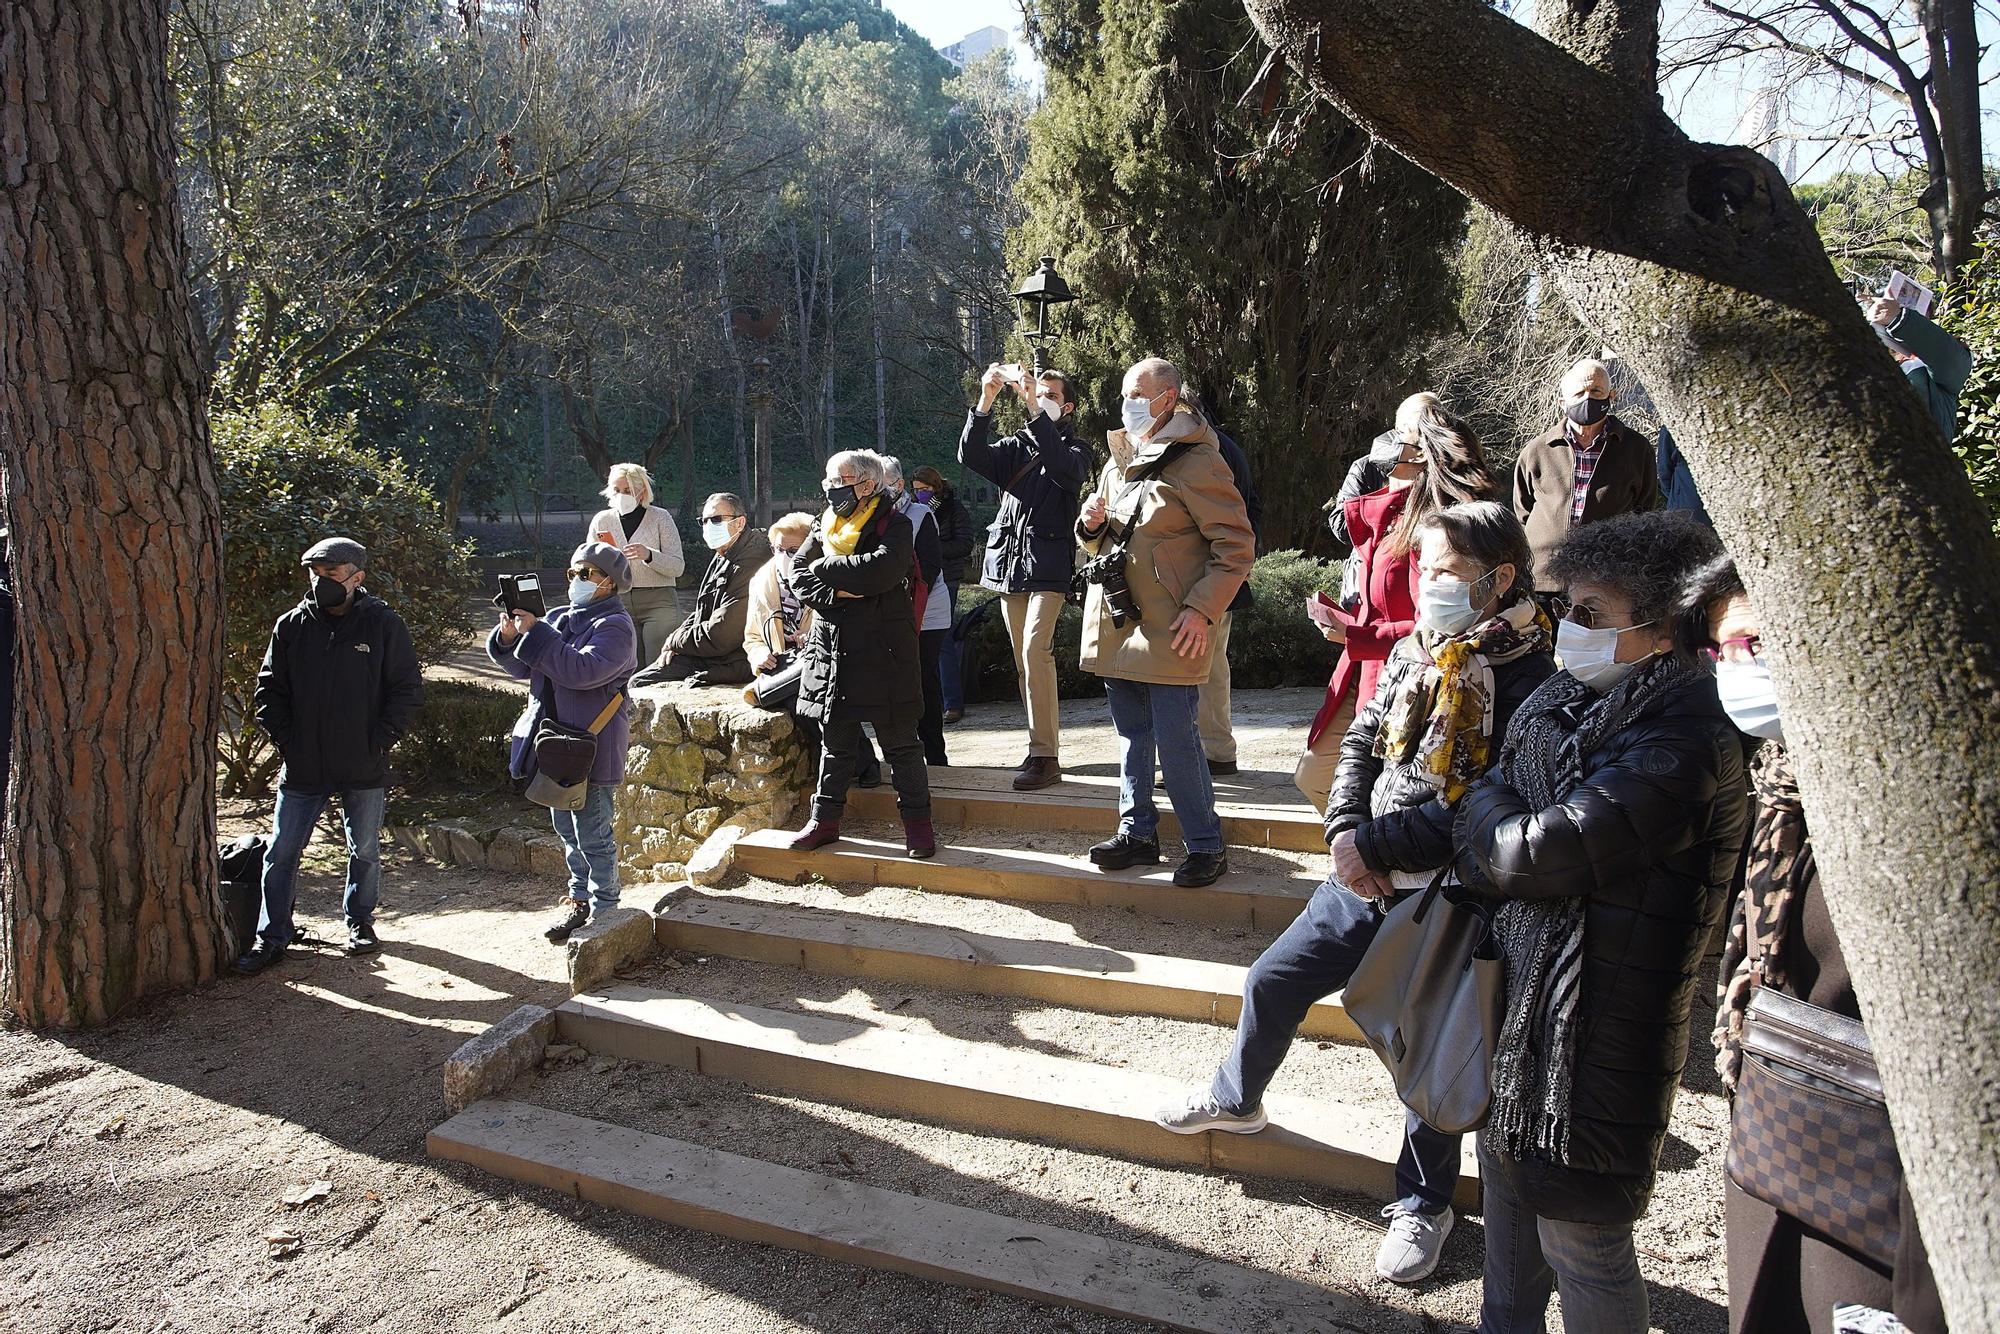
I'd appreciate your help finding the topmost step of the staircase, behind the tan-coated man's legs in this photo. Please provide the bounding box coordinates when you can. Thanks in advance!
[848,768,1326,854]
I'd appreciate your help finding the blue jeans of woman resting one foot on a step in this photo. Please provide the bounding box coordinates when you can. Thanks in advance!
[1208,878,1472,1216]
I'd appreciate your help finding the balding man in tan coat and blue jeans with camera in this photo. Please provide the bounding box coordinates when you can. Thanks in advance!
[1076,358,1256,886]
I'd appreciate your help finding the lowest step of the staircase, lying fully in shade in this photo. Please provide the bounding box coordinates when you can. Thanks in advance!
[426,1098,1414,1334]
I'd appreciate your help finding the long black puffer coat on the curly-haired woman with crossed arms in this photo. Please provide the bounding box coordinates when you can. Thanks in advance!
[1456,674,1746,1224]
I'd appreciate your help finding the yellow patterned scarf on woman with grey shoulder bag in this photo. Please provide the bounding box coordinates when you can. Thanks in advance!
[1374,598,1554,804]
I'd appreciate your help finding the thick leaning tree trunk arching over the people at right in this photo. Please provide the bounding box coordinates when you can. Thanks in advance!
[1248,0,2000,1330]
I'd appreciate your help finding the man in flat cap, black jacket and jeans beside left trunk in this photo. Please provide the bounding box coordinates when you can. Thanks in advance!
[234,538,424,972]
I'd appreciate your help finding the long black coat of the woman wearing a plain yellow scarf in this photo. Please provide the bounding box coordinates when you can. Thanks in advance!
[792,494,924,722]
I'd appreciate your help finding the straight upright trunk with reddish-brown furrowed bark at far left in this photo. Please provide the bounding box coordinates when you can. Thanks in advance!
[0,0,224,1028]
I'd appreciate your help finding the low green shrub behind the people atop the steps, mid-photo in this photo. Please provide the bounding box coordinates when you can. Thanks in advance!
[958,552,1340,702]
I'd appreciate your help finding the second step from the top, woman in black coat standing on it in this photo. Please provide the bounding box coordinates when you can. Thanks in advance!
[736,830,1320,934]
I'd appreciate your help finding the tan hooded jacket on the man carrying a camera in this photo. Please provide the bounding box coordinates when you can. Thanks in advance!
[1076,422,1256,686]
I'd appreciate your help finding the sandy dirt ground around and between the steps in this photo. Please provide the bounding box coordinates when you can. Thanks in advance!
[0,692,1726,1334]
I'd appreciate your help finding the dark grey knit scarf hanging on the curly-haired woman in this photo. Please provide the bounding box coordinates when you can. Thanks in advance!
[1486,656,1700,1164]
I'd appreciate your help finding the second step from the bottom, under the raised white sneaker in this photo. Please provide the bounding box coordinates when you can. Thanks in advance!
[556,986,1478,1206]
